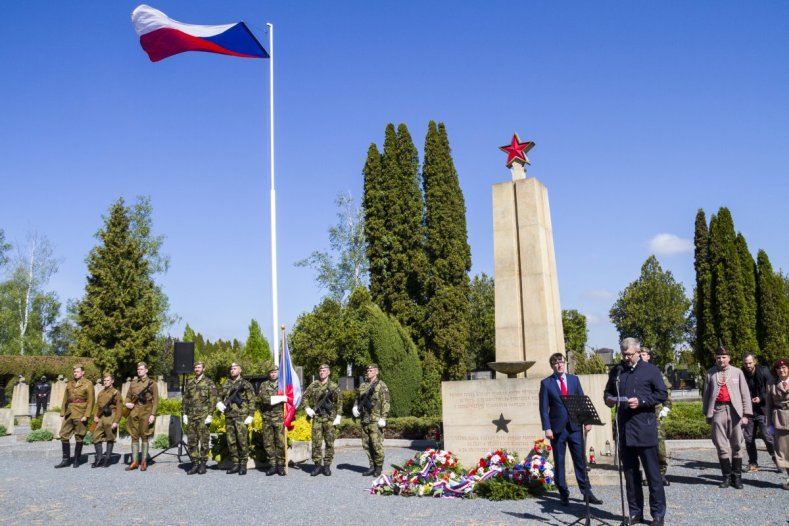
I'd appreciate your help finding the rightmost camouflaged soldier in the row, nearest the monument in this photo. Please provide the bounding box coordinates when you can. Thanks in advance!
[353,363,389,477]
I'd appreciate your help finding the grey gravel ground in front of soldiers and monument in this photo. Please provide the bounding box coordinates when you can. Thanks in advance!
[0,437,789,526]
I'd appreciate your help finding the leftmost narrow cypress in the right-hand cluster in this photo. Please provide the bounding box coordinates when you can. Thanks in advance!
[693,209,717,365]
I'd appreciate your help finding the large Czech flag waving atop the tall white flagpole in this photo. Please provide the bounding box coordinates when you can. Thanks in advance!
[132,4,269,62]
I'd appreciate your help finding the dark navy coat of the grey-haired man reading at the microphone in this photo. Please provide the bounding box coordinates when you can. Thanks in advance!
[604,360,668,447]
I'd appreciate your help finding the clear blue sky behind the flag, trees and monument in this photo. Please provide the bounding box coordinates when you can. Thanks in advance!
[0,0,789,354]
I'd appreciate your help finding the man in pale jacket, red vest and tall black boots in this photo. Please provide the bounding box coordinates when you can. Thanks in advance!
[702,345,753,489]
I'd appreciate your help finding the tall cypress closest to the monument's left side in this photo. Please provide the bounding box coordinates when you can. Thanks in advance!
[422,121,471,380]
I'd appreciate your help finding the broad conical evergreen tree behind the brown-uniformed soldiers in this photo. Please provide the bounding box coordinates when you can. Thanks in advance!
[77,199,163,376]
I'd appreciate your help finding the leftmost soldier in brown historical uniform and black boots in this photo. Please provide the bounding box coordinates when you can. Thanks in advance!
[55,365,94,468]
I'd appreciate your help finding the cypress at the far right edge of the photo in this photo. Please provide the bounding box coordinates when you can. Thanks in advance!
[756,250,789,364]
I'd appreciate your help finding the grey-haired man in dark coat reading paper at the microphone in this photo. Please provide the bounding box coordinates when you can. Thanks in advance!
[604,338,668,526]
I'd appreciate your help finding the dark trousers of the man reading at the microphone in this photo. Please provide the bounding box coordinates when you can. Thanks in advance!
[622,444,666,518]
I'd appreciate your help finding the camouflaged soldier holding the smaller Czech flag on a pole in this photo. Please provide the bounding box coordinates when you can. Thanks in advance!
[258,362,287,477]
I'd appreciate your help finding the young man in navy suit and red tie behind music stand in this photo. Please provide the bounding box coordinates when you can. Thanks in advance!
[540,353,603,506]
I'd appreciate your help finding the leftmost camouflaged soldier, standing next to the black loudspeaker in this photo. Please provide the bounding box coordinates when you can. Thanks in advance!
[183,362,217,475]
